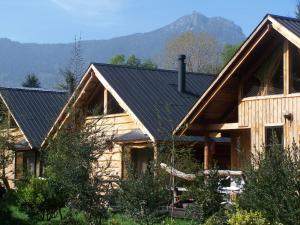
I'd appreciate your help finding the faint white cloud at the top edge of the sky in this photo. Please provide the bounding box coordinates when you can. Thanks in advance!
[51,0,127,16]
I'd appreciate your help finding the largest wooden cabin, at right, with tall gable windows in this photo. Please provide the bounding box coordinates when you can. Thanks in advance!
[174,15,300,169]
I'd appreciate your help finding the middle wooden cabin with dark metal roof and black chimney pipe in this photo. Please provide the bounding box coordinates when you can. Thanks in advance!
[43,60,229,177]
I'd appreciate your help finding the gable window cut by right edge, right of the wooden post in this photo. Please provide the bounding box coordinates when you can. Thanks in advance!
[290,43,300,93]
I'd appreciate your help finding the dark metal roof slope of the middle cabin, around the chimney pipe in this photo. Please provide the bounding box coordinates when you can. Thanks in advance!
[93,63,215,140]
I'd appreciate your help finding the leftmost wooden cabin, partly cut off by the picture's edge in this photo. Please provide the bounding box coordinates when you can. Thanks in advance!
[0,87,67,187]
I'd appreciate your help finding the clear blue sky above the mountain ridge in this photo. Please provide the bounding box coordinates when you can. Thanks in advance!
[0,0,297,43]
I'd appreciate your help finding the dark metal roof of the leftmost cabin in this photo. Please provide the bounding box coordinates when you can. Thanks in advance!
[0,87,67,148]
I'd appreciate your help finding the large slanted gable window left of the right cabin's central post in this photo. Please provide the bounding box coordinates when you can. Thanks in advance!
[242,45,283,97]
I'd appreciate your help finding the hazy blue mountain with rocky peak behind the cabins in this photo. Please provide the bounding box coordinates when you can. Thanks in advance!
[0,12,245,87]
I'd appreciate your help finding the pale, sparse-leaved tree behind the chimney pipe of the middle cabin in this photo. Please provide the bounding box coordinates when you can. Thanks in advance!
[165,32,221,73]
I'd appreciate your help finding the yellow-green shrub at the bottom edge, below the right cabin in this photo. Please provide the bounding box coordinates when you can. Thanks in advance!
[228,209,270,225]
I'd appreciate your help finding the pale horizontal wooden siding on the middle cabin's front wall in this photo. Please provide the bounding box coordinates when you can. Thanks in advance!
[86,113,139,176]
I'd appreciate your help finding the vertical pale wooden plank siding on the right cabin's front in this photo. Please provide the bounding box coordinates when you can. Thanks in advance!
[238,94,300,148]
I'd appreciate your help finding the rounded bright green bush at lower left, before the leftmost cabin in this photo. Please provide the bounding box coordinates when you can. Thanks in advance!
[18,177,64,220]
